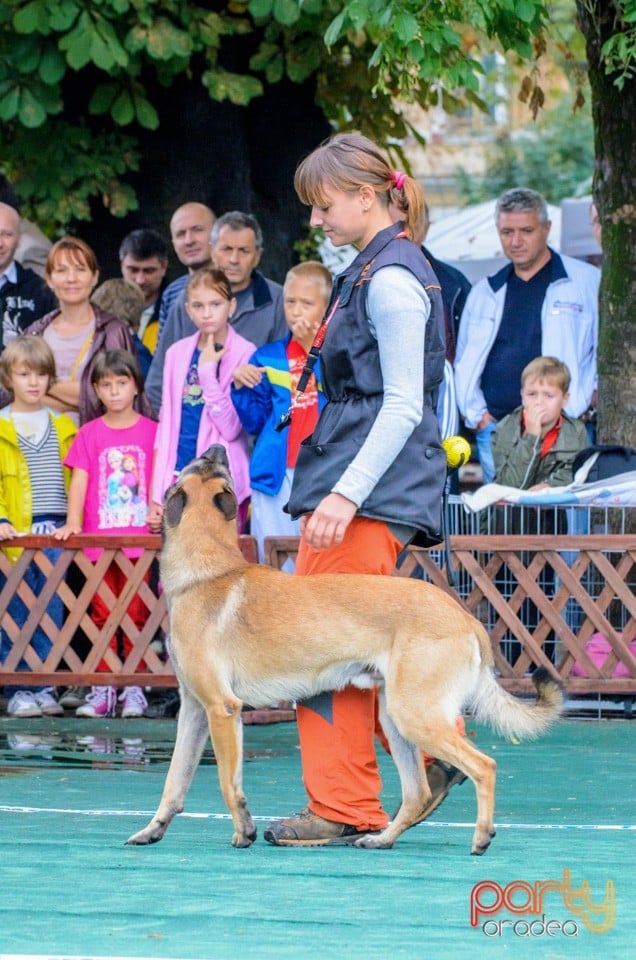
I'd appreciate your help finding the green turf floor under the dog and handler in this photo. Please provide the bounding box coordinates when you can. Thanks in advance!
[0,717,636,960]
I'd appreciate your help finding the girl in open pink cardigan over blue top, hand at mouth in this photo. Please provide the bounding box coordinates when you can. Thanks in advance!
[148,267,256,532]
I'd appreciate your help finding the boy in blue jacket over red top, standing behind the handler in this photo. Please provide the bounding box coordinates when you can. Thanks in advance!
[232,260,332,562]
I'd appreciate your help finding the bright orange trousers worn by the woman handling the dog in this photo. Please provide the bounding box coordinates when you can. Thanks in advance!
[296,517,402,830]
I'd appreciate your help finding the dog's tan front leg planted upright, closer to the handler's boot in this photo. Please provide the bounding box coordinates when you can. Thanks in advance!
[208,697,256,847]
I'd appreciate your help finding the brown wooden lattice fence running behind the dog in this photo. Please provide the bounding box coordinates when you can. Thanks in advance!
[0,535,636,696]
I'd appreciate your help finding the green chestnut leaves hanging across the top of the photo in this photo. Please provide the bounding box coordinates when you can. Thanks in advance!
[0,0,546,227]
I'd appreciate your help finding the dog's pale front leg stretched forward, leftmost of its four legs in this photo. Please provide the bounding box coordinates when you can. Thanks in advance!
[126,686,208,845]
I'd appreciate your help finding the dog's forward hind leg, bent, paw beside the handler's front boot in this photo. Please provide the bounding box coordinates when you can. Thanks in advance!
[355,691,431,849]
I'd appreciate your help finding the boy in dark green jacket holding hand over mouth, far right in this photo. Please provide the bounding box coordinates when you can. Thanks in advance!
[492,357,588,490]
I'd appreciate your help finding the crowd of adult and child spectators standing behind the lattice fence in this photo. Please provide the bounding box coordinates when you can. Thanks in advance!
[0,174,599,717]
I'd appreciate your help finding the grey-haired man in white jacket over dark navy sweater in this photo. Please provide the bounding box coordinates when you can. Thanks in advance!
[455,188,600,483]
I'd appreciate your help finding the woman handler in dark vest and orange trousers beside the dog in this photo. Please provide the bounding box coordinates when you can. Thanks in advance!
[265,134,463,846]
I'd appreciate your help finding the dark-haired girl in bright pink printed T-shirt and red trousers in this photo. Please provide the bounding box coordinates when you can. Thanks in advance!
[55,350,157,717]
